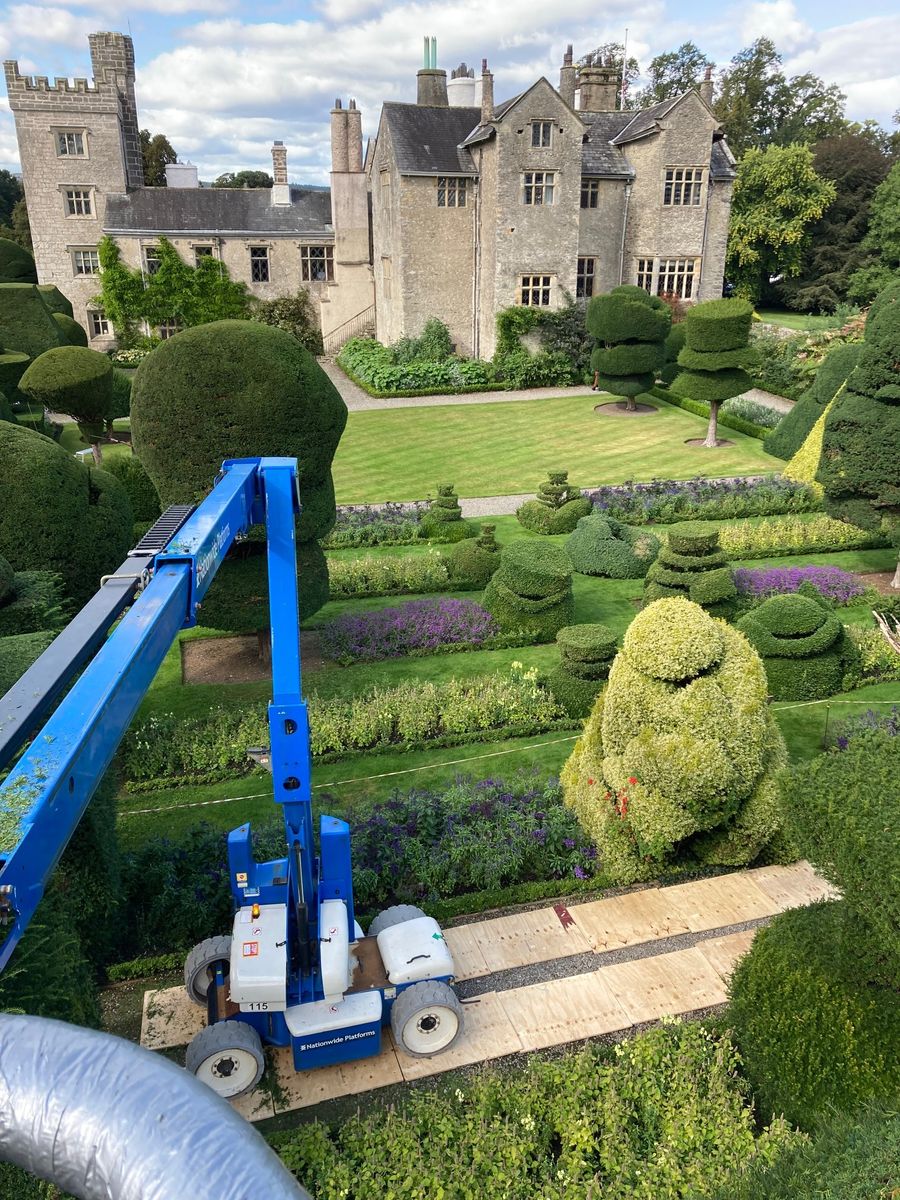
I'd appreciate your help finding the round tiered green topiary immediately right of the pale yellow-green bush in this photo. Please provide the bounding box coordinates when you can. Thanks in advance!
[737,593,858,700]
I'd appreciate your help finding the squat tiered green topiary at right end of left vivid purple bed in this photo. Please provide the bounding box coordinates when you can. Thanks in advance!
[482,538,575,642]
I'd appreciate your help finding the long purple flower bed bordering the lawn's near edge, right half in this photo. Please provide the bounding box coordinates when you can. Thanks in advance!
[586,475,822,524]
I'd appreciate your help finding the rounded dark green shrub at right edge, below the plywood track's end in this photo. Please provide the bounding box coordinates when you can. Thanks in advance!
[728,902,900,1129]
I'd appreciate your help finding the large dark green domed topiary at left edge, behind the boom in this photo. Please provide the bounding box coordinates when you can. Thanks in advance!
[0,421,133,604]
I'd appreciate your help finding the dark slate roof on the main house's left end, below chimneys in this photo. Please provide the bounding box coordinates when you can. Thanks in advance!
[383,101,481,175]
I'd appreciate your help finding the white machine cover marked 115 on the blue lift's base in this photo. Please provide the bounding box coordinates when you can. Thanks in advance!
[229,904,286,1013]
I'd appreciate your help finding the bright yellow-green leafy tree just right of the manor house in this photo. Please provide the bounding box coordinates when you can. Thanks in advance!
[726,145,838,301]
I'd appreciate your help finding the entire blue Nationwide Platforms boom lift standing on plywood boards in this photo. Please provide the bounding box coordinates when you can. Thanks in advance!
[0,458,463,1097]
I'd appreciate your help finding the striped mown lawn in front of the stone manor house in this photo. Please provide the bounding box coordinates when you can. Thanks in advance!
[334,394,784,504]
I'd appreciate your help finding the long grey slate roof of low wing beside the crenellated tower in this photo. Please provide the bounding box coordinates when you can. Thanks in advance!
[103,187,334,236]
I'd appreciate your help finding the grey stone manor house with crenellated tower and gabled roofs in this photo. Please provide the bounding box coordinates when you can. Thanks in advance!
[5,32,734,358]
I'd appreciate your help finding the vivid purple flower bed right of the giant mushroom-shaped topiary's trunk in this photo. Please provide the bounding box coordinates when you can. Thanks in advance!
[322,600,499,662]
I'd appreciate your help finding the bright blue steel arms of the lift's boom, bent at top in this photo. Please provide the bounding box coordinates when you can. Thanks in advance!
[0,458,303,970]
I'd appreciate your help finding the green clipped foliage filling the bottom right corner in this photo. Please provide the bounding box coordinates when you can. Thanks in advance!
[716,1106,900,1200]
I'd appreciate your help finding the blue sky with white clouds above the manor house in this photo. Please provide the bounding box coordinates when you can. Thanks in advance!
[0,0,900,182]
